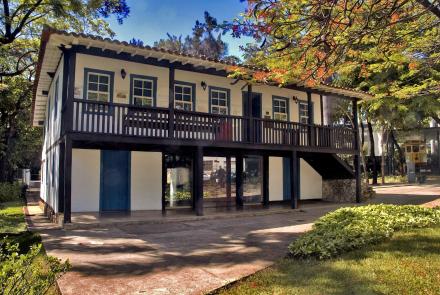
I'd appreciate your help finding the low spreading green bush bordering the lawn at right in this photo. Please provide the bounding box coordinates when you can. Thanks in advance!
[289,205,440,259]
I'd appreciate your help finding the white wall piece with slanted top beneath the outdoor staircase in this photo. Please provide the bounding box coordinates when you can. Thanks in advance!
[300,159,322,200]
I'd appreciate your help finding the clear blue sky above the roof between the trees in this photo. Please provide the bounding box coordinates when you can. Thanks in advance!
[109,0,253,57]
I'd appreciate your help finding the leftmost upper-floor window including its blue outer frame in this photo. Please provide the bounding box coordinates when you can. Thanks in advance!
[84,69,113,102]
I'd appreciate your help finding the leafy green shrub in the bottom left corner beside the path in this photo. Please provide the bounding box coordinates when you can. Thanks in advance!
[0,240,70,295]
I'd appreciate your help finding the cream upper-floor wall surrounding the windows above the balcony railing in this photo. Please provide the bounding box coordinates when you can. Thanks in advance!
[75,54,321,124]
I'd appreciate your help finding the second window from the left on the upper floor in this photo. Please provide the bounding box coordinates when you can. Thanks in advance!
[131,75,156,107]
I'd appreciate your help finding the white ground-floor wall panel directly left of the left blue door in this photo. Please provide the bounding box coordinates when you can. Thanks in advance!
[72,149,101,212]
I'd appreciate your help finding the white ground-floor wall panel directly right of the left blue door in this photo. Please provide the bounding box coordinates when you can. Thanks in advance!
[131,152,162,211]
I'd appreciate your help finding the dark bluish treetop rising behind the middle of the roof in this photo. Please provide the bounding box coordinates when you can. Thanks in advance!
[154,11,239,63]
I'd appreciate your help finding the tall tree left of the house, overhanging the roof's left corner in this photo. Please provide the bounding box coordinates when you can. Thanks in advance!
[0,0,129,181]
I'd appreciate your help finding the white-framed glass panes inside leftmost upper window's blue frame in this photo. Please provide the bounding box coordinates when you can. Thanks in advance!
[86,72,111,102]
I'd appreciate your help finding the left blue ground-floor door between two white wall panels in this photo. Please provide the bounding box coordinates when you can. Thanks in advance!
[100,150,130,212]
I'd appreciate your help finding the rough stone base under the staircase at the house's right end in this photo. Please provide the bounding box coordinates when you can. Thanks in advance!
[322,179,374,203]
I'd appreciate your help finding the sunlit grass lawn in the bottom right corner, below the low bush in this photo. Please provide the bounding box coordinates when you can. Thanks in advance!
[217,227,440,295]
